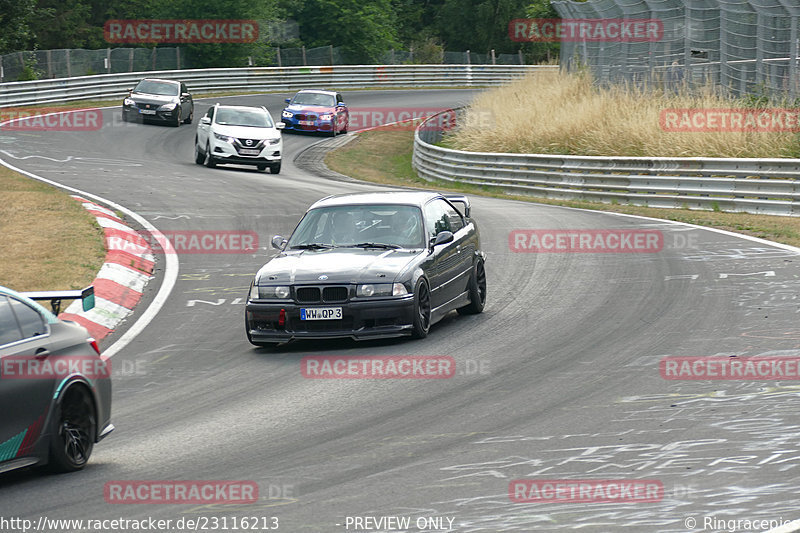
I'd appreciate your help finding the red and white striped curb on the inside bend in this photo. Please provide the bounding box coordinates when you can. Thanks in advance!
[59,195,155,340]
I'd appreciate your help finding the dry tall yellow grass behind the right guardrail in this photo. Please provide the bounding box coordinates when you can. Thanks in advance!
[445,74,800,158]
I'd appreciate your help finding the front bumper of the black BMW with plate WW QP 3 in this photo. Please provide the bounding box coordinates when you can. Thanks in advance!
[245,294,414,342]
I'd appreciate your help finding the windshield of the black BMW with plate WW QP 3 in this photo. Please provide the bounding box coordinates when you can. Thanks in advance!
[287,205,425,249]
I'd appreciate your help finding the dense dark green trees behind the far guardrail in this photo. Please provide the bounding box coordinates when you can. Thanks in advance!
[0,0,557,67]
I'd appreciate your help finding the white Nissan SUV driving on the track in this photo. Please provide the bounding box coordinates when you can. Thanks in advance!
[194,104,283,174]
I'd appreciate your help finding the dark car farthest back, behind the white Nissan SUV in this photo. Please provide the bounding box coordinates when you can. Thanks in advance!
[122,78,194,128]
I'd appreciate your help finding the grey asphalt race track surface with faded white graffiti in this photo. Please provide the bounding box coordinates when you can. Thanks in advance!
[0,90,800,533]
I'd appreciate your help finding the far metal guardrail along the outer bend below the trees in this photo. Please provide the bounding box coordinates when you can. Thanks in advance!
[0,65,558,106]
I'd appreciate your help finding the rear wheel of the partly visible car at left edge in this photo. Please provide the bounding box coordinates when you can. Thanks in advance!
[48,385,97,472]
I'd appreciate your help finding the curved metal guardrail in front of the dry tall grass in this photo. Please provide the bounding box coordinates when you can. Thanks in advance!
[413,108,800,216]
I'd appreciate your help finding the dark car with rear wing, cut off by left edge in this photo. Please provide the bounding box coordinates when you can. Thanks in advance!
[0,287,114,472]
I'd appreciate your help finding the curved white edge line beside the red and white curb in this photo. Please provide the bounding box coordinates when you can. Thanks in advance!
[0,154,179,357]
